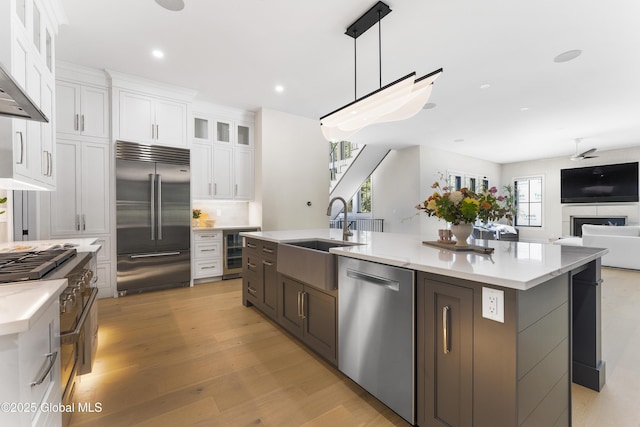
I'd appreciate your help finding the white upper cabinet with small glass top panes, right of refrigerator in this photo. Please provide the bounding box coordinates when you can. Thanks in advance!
[191,115,253,200]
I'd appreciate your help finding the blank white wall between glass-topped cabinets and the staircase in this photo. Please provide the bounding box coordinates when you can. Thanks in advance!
[255,108,329,231]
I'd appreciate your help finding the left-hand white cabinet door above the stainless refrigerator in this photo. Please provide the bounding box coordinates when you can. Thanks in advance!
[118,91,156,144]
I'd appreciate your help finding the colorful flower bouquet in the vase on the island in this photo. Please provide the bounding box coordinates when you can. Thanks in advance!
[416,182,507,225]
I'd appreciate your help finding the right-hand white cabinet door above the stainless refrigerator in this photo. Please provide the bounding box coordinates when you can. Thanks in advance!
[155,99,187,147]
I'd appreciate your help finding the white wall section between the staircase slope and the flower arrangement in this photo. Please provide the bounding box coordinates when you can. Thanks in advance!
[371,146,422,234]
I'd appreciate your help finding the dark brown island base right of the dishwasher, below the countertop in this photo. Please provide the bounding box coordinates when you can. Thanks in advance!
[416,258,605,427]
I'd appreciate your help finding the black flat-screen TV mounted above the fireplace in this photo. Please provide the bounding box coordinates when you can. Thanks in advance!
[560,162,638,203]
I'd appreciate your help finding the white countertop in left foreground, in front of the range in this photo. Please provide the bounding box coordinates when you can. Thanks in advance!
[0,279,67,336]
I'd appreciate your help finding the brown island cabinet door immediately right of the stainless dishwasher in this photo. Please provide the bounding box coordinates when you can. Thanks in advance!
[417,279,473,427]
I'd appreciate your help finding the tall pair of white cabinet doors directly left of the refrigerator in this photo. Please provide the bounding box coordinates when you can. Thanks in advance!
[50,139,110,237]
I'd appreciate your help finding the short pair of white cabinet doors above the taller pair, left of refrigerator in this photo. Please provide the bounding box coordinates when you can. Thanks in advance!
[56,80,109,138]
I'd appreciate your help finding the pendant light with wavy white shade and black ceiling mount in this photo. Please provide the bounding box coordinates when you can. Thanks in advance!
[320,1,442,141]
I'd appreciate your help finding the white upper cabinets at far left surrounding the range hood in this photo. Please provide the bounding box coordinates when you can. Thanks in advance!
[0,0,57,190]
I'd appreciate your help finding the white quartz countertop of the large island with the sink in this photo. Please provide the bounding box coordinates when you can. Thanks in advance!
[241,229,608,290]
